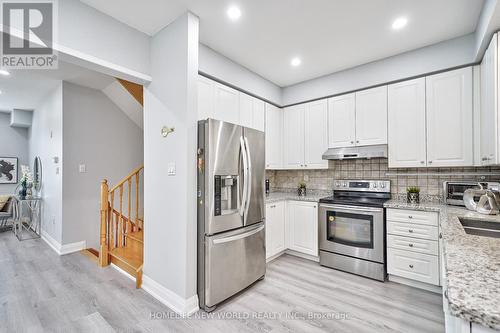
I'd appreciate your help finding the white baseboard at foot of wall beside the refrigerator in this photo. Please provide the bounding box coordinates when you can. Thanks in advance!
[142,275,199,316]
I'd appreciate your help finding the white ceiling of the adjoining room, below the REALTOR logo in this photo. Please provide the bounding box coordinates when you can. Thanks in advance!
[0,61,114,112]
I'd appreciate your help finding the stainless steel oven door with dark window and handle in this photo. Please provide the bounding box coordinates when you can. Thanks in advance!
[318,204,384,263]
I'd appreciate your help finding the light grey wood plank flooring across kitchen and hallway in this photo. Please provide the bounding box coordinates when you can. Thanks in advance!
[0,232,444,333]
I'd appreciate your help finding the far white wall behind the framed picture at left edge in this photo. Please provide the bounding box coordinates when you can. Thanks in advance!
[0,112,30,195]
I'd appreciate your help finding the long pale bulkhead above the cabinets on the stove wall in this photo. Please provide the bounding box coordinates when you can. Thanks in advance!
[283,34,475,105]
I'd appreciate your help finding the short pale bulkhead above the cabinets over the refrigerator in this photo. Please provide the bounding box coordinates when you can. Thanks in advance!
[199,44,281,105]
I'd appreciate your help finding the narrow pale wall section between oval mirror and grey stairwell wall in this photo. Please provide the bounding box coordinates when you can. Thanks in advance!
[29,82,63,243]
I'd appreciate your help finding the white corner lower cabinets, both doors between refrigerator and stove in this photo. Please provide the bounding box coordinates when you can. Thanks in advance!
[266,201,318,259]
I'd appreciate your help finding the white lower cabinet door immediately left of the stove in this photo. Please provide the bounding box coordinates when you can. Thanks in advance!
[287,201,318,257]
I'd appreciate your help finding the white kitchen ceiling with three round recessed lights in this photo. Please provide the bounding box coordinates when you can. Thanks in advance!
[81,0,483,86]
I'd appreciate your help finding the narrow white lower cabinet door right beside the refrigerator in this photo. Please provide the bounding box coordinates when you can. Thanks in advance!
[266,201,286,259]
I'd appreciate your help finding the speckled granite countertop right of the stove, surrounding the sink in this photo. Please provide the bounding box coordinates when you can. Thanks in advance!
[385,199,500,330]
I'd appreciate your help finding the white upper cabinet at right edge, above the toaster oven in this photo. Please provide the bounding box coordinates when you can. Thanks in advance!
[479,34,499,165]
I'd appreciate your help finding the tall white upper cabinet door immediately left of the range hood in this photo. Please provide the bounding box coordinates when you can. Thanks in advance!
[304,99,328,168]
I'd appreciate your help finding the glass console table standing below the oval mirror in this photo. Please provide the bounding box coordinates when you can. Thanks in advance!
[12,196,42,241]
